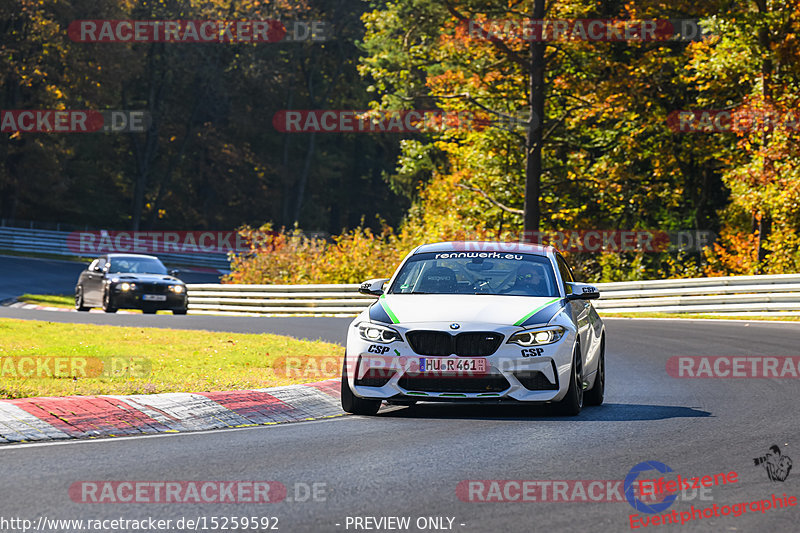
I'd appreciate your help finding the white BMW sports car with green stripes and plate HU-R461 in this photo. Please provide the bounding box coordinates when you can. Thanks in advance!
[342,242,605,415]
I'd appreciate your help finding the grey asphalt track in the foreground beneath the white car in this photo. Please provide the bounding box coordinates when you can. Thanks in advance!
[0,313,800,533]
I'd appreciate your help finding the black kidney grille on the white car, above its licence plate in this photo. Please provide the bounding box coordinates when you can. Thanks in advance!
[406,331,503,357]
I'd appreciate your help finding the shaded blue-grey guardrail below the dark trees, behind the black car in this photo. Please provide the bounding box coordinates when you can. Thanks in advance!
[0,226,230,270]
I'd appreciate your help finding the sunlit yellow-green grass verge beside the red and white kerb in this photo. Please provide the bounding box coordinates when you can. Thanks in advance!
[0,319,344,398]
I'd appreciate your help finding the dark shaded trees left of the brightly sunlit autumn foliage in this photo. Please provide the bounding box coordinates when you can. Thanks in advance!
[0,0,400,233]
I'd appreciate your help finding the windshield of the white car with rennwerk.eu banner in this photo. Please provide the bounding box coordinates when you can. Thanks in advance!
[389,252,559,297]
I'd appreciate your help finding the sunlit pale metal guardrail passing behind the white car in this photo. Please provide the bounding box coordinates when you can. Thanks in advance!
[188,274,800,316]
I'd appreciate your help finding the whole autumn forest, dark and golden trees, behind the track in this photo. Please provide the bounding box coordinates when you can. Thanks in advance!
[0,0,800,281]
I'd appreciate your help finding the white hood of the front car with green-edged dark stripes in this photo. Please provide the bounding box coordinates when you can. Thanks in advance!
[376,294,561,325]
